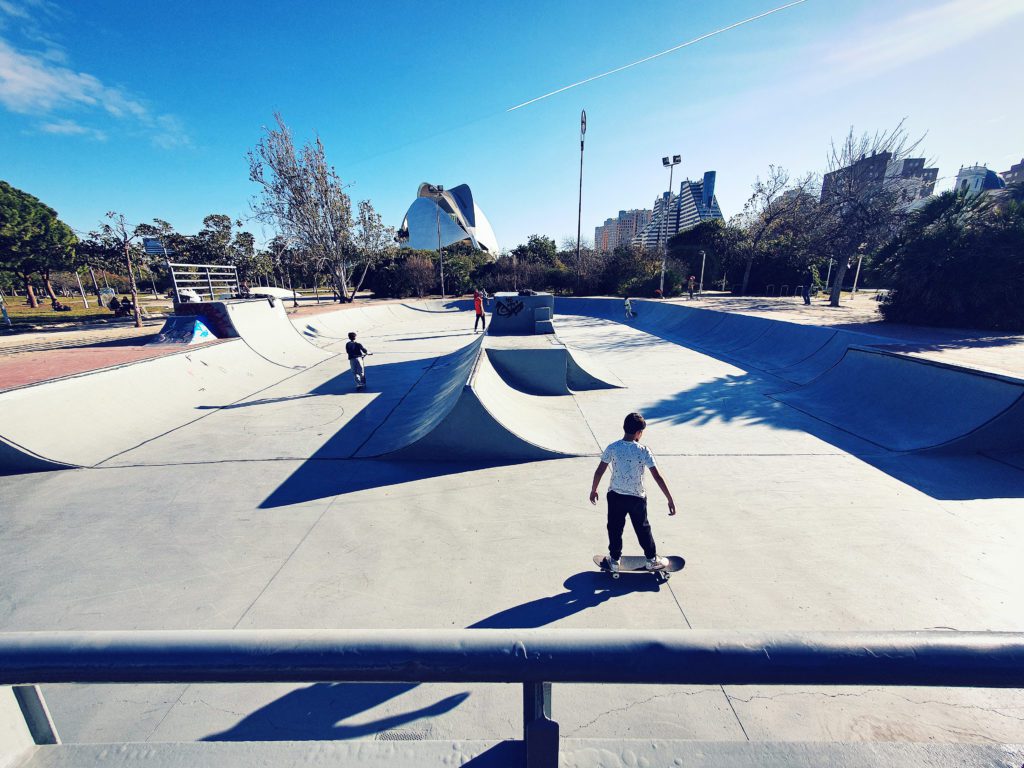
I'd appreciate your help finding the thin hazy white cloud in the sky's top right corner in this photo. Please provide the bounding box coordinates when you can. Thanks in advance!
[824,0,1024,75]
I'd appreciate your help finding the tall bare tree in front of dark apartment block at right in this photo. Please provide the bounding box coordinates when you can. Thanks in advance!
[818,121,924,307]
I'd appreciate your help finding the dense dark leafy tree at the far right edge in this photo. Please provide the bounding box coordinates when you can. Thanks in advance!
[879,184,1024,332]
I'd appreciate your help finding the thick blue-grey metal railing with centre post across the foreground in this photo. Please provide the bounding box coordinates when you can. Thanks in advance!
[0,629,1024,766]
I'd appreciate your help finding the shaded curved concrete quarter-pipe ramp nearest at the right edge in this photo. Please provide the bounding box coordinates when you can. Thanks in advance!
[772,347,1024,453]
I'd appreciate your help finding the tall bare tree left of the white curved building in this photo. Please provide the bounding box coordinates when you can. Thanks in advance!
[249,113,354,301]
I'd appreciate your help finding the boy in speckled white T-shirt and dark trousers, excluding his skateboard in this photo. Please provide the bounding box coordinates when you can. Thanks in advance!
[590,414,676,573]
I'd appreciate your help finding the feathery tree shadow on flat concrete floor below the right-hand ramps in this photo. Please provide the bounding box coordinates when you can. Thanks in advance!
[641,374,1024,501]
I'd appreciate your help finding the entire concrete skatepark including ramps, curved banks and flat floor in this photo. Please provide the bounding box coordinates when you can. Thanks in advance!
[0,298,1024,765]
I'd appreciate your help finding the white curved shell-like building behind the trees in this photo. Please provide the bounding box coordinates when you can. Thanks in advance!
[398,182,498,255]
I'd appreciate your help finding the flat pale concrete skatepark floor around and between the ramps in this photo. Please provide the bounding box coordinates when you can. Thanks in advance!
[0,302,1024,753]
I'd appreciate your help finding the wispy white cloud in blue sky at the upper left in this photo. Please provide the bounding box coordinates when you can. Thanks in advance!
[0,35,189,148]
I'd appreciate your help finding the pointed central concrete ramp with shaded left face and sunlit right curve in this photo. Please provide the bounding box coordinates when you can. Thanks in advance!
[356,336,598,462]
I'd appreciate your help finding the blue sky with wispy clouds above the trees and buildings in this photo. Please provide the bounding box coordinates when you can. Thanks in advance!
[0,0,1024,248]
